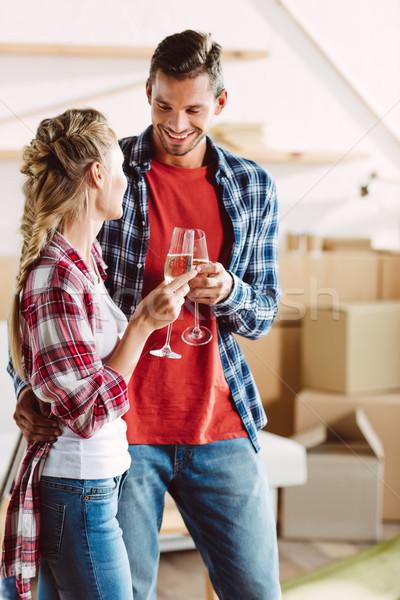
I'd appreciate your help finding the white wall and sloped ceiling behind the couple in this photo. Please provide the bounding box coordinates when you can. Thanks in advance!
[0,0,400,255]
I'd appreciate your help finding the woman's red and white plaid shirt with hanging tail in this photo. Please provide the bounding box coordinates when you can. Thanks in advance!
[1,233,129,600]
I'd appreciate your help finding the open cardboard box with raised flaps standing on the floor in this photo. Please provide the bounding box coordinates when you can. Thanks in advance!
[281,408,384,541]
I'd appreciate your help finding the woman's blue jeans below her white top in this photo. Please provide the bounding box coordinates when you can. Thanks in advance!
[37,475,132,600]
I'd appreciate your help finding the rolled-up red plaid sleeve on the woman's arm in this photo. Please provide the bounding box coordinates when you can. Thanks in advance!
[26,289,129,437]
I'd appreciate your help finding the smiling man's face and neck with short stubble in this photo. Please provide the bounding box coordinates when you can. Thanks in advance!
[146,71,227,168]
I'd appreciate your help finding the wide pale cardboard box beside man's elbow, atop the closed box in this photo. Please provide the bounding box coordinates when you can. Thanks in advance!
[277,250,380,325]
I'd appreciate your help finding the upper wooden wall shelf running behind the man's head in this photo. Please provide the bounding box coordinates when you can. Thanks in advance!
[0,43,268,60]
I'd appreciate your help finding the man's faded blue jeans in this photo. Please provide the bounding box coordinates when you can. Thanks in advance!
[118,438,282,600]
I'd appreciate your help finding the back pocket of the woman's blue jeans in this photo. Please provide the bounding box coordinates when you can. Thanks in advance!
[39,500,65,558]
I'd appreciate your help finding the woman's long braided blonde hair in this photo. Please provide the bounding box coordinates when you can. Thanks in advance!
[9,108,117,380]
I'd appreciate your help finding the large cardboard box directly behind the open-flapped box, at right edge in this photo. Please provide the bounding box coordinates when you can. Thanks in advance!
[294,390,400,521]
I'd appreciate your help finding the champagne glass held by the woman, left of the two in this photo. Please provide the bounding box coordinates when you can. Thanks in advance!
[150,227,194,358]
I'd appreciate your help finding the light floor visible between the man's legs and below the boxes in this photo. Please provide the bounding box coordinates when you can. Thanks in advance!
[157,522,400,600]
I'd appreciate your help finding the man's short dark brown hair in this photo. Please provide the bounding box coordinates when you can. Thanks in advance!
[149,29,224,98]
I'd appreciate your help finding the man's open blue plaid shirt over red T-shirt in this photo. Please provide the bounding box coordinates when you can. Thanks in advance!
[98,126,280,450]
